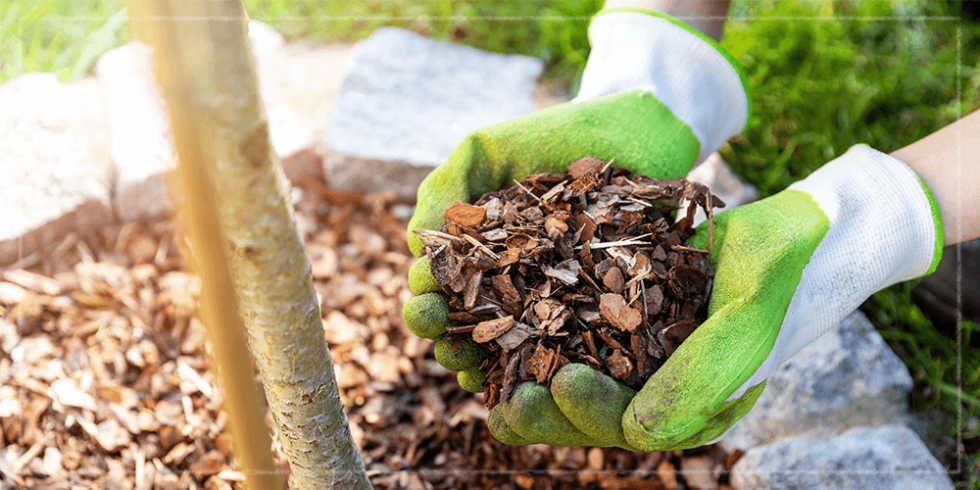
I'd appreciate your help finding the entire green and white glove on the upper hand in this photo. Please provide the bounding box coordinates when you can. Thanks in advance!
[403,11,750,440]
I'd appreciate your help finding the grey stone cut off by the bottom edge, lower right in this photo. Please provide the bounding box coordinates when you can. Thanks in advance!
[732,425,953,490]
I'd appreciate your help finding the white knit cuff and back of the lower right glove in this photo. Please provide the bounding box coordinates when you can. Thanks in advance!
[729,145,943,400]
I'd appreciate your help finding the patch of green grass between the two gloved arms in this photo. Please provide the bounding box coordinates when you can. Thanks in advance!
[722,2,980,196]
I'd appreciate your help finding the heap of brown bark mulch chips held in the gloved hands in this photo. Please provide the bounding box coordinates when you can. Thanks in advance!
[415,157,724,408]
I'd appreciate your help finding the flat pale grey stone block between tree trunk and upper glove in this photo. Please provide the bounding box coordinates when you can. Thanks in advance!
[322,27,543,199]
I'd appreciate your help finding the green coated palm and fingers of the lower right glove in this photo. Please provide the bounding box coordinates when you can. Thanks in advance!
[489,191,829,451]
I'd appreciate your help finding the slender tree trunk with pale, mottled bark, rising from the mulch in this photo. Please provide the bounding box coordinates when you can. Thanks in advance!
[133,0,371,489]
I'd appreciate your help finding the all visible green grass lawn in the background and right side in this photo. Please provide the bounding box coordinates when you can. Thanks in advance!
[0,0,980,489]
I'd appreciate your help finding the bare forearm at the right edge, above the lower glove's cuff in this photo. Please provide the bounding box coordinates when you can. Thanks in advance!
[891,111,980,245]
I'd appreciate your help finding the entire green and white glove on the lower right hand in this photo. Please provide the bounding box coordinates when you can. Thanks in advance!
[490,145,943,451]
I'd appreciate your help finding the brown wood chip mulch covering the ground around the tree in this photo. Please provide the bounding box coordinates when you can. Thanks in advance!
[0,178,737,490]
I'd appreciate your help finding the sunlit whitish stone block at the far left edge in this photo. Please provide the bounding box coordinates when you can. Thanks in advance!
[0,73,113,268]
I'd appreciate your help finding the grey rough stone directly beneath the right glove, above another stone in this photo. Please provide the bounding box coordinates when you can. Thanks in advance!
[720,311,912,450]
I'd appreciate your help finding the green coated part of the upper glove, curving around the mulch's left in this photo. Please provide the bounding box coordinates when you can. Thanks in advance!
[402,90,700,384]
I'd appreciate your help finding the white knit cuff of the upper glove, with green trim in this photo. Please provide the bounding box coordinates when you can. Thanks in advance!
[574,11,749,162]
